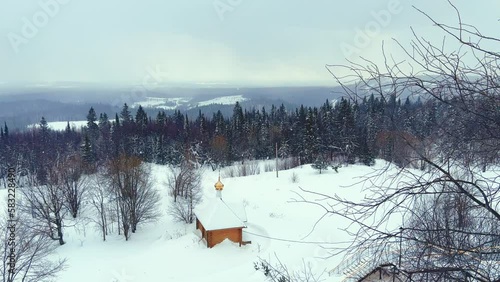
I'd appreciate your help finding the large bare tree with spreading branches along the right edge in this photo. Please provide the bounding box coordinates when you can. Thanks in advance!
[299,1,500,281]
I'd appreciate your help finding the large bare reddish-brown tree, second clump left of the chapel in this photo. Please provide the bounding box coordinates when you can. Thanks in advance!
[107,156,160,240]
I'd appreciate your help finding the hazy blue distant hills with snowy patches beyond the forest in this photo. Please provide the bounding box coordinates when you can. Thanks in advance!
[0,85,352,130]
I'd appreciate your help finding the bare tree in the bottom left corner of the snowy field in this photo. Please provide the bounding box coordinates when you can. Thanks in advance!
[0,213,66,282]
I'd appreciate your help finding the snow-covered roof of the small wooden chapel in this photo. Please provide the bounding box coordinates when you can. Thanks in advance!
[195,197,246,230]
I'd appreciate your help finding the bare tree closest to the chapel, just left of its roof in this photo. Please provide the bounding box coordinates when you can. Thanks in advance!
[168,161,201,223]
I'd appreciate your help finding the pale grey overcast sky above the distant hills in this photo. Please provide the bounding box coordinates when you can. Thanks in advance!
[0,0,500,85]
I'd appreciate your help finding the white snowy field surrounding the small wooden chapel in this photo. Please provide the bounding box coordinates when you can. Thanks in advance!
[0,161,402,282]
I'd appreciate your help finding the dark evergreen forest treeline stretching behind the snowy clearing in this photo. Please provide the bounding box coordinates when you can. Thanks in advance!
[0,92,456,180]
